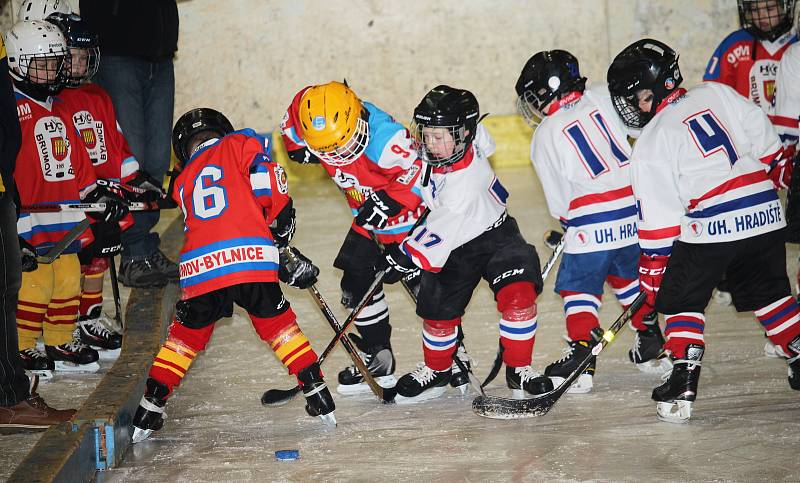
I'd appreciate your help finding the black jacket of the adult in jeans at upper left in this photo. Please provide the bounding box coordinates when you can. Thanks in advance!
[80,0,178,62]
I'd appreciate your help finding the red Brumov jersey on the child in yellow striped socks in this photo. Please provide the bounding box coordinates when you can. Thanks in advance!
[14,87,96,254]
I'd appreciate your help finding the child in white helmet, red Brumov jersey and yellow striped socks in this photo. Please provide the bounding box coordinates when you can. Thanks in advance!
[6,21,127,373]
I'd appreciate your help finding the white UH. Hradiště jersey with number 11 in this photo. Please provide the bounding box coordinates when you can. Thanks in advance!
[531,84,638,253]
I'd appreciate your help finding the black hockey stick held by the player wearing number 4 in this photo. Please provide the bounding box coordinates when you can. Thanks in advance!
[472,292,647,419]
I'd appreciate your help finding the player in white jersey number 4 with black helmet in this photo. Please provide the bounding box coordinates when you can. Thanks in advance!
[608,39,800,422]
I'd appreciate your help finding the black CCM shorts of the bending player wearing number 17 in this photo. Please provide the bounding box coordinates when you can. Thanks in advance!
[417,216,542,320]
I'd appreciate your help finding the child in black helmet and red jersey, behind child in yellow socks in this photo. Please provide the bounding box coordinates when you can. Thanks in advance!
[47,13,164,356]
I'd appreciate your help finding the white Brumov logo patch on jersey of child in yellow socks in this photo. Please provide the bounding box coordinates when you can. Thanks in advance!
[33,116,75,181]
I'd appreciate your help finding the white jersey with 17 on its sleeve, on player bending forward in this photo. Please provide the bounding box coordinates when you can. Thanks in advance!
[400,124,508,272]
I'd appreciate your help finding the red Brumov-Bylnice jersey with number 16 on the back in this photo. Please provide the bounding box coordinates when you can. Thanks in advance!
[173,129,289,299]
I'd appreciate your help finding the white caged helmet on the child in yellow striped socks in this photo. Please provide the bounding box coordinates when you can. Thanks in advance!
[5,20,70,95]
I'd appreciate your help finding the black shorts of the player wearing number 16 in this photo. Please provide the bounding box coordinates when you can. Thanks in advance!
[175,282,289,329]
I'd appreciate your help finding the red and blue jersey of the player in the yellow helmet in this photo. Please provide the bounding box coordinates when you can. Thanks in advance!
[281,87,425,243]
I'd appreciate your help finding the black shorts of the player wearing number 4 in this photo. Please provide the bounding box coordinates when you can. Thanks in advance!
[656,230,791,314]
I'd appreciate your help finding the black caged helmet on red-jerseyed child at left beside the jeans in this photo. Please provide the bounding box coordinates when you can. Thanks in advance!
[47,13,100,87]
